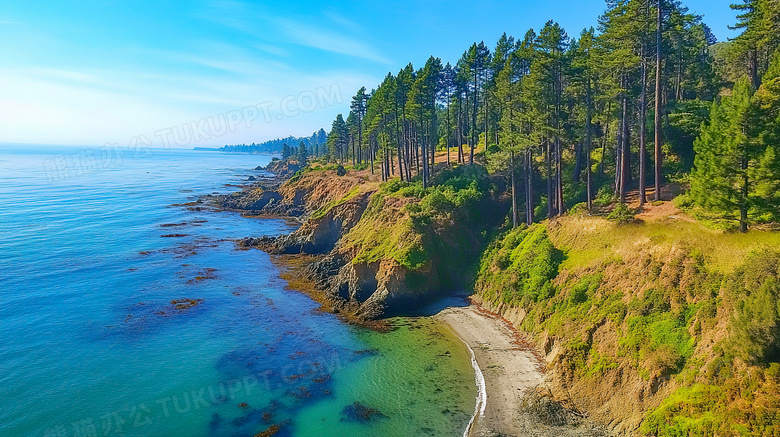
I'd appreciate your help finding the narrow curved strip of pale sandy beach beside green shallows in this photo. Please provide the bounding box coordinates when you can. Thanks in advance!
[435,305,544,436]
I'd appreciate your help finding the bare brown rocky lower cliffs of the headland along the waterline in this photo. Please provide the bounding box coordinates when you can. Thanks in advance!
[202,166,466,322]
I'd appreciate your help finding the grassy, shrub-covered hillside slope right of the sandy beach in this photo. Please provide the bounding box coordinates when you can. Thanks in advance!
[476,216,780,436]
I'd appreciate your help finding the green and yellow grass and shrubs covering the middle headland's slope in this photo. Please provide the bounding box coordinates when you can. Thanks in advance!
[338,165,492,272]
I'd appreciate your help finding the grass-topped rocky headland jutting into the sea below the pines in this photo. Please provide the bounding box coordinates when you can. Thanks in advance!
[221,164,500,320]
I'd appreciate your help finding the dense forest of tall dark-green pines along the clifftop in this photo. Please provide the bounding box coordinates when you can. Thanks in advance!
[316,0,780,232]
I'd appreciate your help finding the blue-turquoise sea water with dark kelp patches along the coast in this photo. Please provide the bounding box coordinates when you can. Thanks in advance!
[0,146,476,436]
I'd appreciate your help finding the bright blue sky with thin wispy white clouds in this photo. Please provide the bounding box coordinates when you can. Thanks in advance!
[0,0,735,148]
